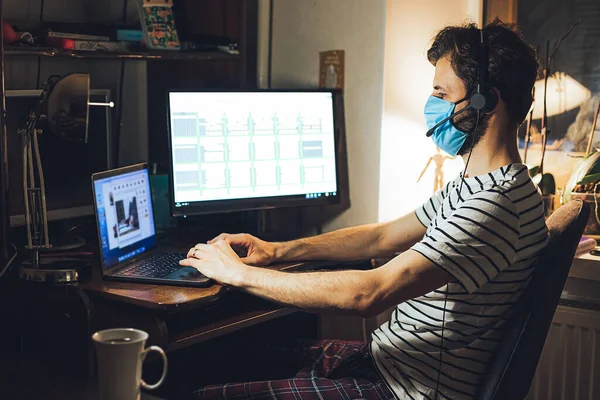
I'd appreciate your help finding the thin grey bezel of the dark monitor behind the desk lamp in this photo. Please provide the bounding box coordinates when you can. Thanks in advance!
[6,89,114,227]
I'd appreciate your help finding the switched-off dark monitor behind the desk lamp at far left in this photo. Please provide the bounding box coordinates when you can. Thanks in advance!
[6,89,113,226]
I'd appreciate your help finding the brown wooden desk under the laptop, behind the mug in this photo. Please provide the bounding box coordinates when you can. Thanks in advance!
[79,262,370,351]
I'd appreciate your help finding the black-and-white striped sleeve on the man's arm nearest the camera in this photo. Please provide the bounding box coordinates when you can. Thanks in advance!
[412,191,519,293]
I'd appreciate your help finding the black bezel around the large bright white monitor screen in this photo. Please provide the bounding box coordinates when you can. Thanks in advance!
[166,88,342,217]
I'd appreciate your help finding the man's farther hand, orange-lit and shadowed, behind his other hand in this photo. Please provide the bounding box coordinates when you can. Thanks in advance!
[208,233,276,265]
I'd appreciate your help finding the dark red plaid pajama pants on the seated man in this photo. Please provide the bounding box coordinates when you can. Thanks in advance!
[193,340,394,400]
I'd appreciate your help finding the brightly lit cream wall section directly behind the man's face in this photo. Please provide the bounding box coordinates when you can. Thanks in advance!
[378,0,482,221]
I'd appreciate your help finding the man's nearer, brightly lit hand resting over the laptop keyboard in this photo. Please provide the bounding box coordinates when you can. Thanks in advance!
[179,240,249,286]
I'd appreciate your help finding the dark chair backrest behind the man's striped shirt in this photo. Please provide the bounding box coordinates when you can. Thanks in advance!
[476,200,590,400]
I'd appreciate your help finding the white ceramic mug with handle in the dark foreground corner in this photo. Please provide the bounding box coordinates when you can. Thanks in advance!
[92,328,167,400]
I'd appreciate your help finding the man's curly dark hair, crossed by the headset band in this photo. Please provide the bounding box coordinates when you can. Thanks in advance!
[427,18,539,125]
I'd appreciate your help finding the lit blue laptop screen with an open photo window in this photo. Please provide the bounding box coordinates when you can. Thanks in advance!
[93,167,156,268]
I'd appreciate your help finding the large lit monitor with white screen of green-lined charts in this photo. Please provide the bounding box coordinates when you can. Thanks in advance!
[167,90,340,216]
